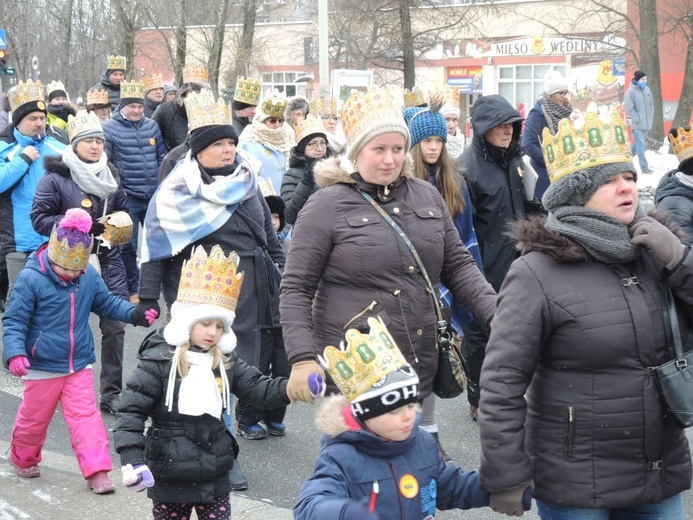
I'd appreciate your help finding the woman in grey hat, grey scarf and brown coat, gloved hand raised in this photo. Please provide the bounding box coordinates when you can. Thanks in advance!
[479,111,693,520]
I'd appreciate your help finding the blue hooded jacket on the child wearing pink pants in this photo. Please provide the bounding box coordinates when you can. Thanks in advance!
[2,244,135,374]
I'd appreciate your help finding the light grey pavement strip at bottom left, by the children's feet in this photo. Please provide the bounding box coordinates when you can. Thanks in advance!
[0,441,293,520]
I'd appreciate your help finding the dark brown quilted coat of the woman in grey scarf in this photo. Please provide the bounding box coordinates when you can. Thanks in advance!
[479,214,693,508]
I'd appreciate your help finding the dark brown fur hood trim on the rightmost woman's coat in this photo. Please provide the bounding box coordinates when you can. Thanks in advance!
[509,210,686,263]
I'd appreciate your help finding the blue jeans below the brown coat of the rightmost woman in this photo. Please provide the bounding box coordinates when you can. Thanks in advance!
[536,493,683,520]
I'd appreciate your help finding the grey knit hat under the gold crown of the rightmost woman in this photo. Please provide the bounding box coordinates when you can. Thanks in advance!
[541,162,638,212]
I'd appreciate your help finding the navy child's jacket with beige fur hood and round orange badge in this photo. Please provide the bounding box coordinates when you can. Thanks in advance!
[294,396,490,520]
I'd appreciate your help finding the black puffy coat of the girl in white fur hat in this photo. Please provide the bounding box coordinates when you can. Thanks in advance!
[113,329,289,503]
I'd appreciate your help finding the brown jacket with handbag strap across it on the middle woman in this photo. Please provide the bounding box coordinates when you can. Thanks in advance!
[280,154,496,396]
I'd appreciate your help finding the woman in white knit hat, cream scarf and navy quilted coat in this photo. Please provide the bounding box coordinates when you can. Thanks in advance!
[31,111,128,413]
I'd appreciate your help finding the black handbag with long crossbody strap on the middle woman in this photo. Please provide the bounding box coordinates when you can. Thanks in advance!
[358,190,467,399]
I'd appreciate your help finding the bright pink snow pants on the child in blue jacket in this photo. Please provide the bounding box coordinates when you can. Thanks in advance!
[10,369,113,478]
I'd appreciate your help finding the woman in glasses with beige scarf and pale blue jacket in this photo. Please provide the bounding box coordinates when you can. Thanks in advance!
[238,89,294,193]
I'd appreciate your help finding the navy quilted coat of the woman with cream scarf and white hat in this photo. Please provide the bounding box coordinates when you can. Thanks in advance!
[31,156,129,300]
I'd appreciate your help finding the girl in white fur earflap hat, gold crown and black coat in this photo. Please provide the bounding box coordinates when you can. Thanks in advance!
[113,245,289,520]
